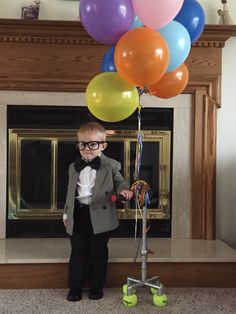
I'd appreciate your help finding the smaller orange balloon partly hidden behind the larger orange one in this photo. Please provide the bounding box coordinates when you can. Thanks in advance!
[147,63,189,98]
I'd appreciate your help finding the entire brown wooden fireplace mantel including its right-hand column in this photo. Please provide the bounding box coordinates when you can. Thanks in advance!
[0,19,236,239]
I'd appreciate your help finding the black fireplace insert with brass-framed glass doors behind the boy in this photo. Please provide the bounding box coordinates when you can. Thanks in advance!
[6,105,173,238]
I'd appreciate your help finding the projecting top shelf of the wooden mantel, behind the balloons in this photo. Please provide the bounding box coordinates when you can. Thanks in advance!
[0,19,236,47]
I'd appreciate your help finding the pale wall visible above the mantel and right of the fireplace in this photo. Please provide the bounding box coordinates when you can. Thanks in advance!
[0,0,236,249]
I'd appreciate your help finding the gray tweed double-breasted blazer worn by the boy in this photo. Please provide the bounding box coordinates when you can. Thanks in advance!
[64,154,129,235]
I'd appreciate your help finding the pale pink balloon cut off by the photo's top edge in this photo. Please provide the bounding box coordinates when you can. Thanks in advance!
[132,0,184,29]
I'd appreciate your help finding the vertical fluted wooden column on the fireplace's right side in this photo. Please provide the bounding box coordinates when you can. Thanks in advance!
[191,89,217,240]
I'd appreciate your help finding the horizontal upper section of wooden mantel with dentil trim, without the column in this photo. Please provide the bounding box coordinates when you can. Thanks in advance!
[0,19,236,91]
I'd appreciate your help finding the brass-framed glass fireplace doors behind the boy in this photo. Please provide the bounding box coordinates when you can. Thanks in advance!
[8,129,171,220]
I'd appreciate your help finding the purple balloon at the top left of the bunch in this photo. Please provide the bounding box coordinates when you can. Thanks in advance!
[79,0,134,45]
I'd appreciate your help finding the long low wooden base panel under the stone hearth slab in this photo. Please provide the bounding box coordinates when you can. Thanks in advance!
[0,262,236,289]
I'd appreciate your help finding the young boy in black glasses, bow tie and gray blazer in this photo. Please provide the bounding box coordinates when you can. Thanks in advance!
[63,122,132,301]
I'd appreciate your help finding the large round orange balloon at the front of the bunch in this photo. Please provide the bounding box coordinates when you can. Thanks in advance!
[114,27,169,87]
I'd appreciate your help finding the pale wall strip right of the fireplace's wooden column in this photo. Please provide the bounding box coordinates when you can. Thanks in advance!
[216,37,236,249]
